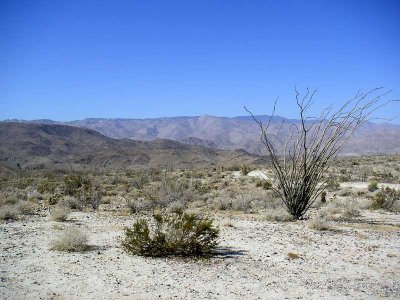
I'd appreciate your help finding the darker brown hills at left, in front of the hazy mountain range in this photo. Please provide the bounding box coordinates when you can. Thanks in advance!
[0,122,263,173]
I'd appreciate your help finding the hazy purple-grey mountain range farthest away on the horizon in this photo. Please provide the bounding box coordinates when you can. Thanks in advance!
[3,115,400,155]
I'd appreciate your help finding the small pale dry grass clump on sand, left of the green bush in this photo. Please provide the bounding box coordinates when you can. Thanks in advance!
[50,227,90,252]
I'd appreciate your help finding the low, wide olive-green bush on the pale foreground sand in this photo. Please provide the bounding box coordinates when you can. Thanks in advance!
[122,214,219,257]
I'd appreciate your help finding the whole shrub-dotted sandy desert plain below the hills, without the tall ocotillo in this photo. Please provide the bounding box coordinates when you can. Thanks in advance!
[0,155,400,298]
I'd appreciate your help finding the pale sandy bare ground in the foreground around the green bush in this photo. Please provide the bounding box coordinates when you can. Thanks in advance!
[0,212,400,299]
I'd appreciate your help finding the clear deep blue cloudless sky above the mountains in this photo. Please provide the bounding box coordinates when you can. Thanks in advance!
[0,0,400,123]
